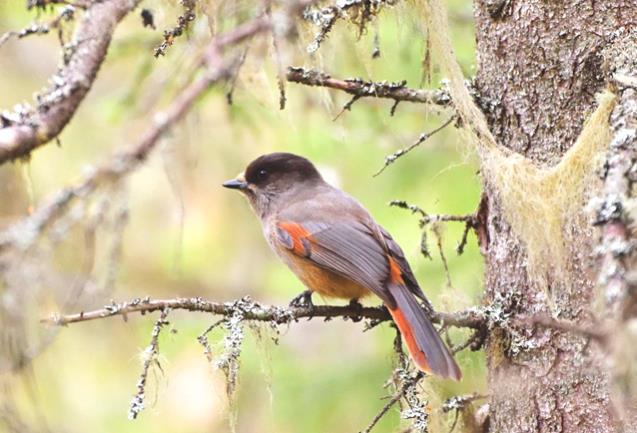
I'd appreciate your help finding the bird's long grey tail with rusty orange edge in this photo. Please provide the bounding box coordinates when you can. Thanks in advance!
[388,283,462,380]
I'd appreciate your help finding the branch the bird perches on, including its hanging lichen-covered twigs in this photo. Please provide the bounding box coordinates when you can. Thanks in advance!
[41,296,486,426]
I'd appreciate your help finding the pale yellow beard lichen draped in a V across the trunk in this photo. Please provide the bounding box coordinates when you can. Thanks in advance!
[415,0,616,300]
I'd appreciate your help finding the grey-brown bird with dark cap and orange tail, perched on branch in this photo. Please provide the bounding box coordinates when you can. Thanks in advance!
[222,152,462,380]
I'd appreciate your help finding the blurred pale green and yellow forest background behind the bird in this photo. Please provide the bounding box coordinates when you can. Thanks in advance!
[0,0,485,433]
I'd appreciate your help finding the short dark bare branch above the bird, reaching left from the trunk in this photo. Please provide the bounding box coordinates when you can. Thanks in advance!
[286,67,451,107]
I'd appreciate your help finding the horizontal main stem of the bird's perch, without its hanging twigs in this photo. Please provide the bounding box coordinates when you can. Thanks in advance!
[42,297,484,329]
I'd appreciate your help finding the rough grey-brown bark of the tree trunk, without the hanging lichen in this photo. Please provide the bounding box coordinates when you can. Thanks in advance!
[474,0,637,433]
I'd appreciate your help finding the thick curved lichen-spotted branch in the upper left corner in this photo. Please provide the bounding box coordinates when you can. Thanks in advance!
[0,0,139,164]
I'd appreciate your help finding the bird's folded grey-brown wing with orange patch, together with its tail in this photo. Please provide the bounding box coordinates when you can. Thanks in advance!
[276,219,462,380]
